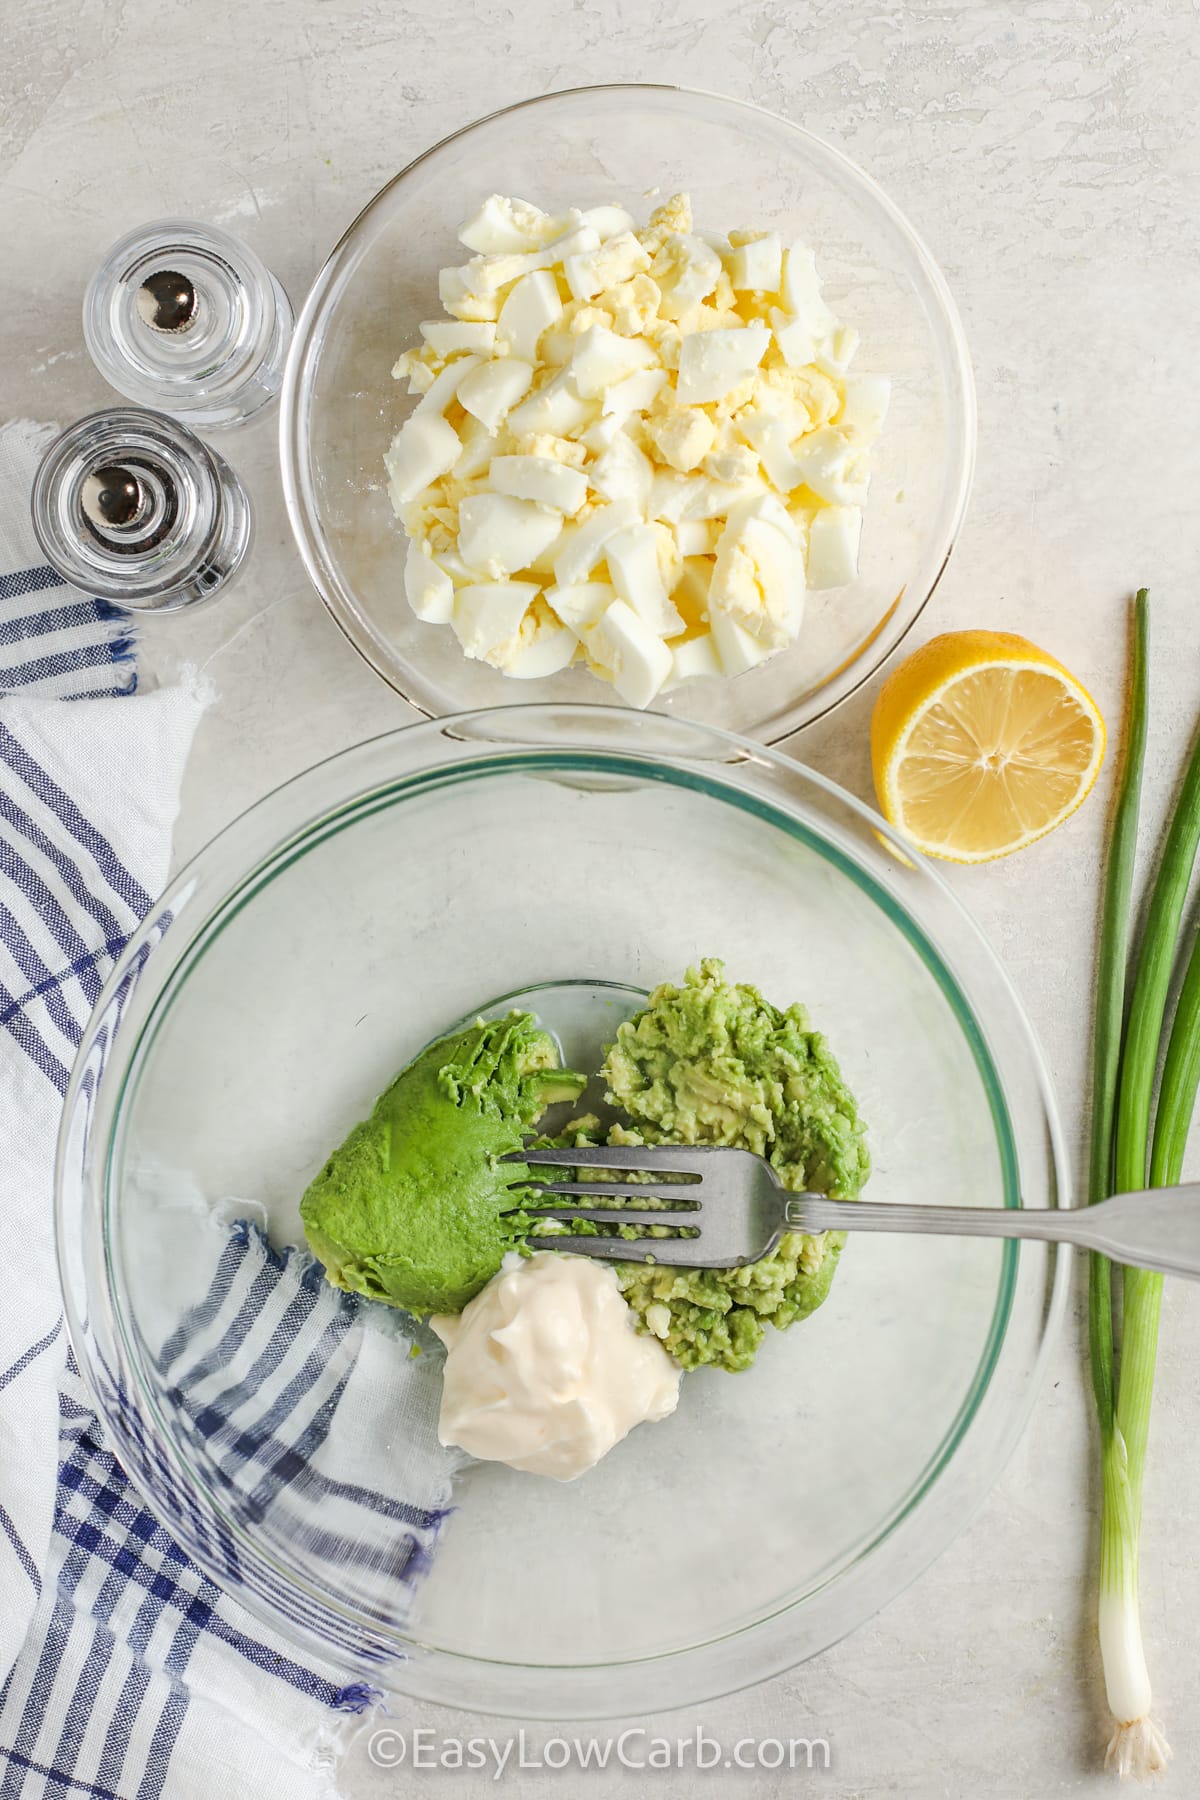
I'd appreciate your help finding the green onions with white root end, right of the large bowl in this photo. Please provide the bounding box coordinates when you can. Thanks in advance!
[1088,590,1200,1777]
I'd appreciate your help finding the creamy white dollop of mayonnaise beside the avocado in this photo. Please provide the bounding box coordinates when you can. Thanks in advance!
[430,1251,680,1481]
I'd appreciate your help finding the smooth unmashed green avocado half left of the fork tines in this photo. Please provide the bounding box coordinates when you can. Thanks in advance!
[300,1013,587,1314]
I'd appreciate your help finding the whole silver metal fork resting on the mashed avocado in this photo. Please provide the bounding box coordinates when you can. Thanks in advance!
[504,1145,1200,1278]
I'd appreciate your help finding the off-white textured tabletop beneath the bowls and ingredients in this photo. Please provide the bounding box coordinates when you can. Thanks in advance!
[0,0,1200,1800]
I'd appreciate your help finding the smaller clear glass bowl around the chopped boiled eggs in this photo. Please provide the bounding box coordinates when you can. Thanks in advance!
[281,86,975,742]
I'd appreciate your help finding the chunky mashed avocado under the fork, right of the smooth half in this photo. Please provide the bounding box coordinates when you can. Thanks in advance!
[600,959,871,1370]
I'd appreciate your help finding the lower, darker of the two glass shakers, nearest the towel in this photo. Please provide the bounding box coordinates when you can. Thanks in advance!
[31,407,250,612]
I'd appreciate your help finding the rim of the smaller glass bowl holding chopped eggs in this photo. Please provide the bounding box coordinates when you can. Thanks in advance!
[279,81,979,745]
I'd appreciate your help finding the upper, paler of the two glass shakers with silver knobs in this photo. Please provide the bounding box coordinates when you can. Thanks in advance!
[83,220,291,428]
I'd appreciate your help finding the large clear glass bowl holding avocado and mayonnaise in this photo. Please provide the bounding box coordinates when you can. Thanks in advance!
[58,706,1065,1717]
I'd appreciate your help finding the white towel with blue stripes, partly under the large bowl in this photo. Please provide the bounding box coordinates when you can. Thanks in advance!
[0,425,448,1800]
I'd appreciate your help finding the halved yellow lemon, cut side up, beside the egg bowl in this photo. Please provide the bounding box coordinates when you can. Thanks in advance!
[871,632,1105,862]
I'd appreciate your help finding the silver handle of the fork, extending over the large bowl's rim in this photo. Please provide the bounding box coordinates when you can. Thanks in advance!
[784,1181,1200,1280]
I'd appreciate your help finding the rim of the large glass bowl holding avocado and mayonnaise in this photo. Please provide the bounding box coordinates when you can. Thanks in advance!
[56,704,1070,1719]
